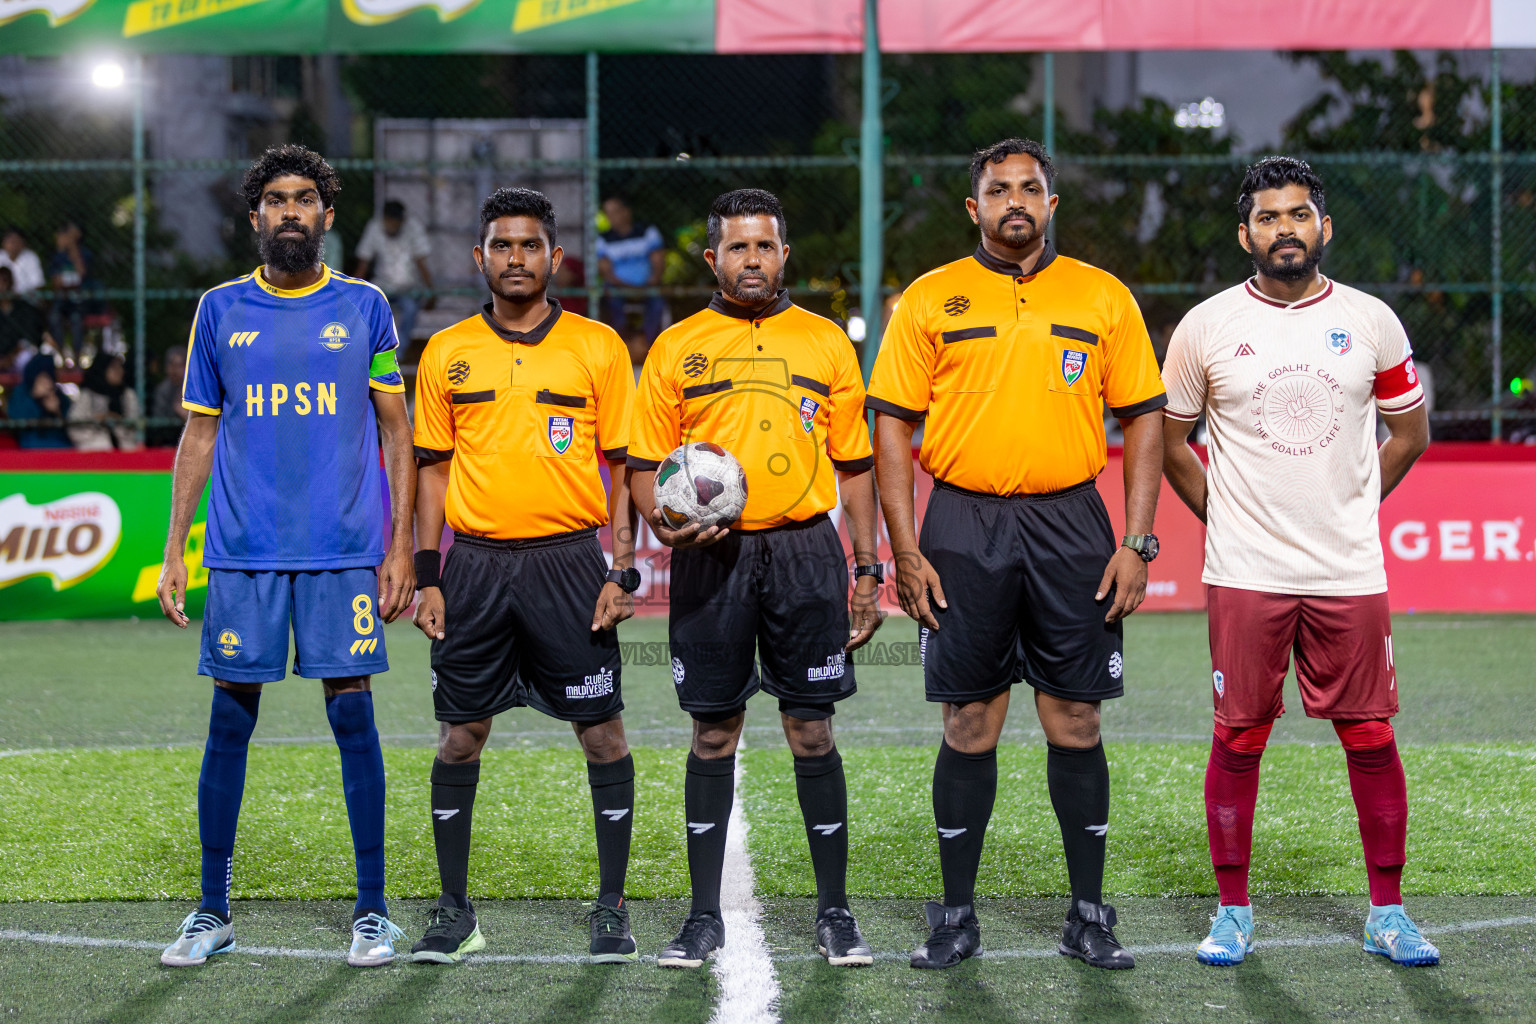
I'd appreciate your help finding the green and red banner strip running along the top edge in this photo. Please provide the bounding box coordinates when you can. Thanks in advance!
[0,0,1536,54]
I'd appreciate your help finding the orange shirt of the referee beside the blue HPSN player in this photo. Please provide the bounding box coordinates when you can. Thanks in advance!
[415,299,634,540]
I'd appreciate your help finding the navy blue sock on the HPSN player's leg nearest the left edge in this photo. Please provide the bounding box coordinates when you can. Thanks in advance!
[197,686,261,918]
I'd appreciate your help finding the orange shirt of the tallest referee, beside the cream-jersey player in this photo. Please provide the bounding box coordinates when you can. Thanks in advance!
[866,243,1167,494]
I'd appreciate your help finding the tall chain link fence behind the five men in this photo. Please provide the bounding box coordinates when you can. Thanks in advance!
[0,54,1536,444]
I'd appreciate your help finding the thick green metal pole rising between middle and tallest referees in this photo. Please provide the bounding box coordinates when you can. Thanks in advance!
[859,0,885,381]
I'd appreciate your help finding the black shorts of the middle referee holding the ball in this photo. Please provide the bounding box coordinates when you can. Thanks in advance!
[668,514,856,720]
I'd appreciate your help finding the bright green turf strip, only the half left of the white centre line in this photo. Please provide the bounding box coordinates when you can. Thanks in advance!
[0,745,688,901]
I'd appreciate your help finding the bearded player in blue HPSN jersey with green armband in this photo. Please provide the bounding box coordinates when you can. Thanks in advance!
[158,146,416,967]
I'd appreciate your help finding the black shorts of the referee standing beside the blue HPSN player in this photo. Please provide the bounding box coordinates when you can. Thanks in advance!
[432,530,624,722]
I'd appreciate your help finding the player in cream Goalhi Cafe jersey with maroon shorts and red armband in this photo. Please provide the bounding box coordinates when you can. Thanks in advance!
[1163,157,1439,966]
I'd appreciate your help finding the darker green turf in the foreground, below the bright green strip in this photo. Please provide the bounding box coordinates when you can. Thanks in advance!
[0,897,1536,1024]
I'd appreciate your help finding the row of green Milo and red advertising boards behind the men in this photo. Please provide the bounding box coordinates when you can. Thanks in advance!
[0,445,1536,620]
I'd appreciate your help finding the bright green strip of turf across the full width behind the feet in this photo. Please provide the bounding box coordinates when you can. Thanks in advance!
[0,743,1536,901]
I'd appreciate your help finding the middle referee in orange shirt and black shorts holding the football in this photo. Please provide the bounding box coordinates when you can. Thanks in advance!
[628,189,883,967]
